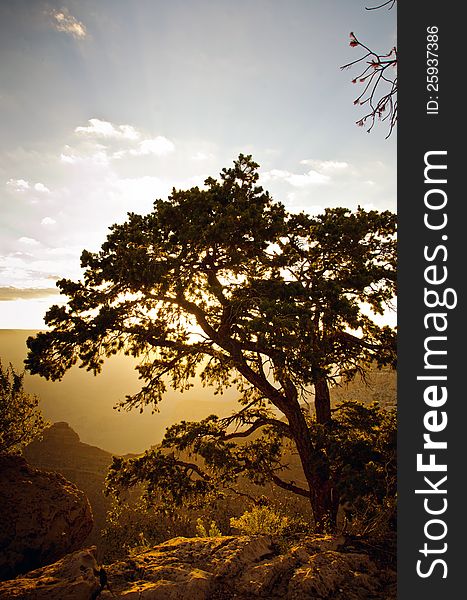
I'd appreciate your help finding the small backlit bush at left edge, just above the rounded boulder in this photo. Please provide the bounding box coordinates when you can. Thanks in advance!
[0,360,45,454]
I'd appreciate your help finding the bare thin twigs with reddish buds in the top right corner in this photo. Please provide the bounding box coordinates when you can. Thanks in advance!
[341,0,398,137]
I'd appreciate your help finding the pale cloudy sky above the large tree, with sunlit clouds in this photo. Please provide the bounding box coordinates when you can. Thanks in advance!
[0,0,396,329]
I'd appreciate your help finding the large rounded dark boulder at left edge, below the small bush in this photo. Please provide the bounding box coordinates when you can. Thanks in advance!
[0,455,92,579]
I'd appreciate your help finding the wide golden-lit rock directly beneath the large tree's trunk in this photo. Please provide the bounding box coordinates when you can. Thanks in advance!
[99,536,396,600]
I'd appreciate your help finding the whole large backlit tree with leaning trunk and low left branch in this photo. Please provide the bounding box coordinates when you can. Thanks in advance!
[26,155,396,530]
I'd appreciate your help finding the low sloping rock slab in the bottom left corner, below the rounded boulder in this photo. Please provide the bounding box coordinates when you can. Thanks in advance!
[0,547,102,600]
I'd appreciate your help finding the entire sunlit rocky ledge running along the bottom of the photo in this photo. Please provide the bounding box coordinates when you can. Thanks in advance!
[0,536,396,600]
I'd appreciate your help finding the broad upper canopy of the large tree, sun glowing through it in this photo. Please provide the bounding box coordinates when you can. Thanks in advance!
[26,155,395,407]
